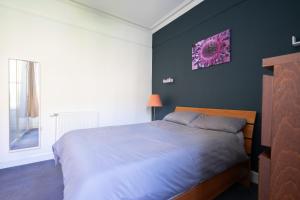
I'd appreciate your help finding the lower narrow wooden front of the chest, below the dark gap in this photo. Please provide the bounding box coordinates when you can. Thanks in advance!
[258,153,271,200]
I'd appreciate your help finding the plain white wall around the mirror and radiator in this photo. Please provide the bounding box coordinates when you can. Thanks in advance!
[0,0,152,168]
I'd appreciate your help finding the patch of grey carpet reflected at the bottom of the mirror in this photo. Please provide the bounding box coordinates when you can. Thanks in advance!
[10,128,39,150]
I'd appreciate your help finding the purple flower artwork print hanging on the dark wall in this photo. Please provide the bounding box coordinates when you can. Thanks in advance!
[192,29,230,70]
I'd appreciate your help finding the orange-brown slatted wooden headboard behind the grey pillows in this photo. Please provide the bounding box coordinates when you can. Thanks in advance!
[175,107,256,154]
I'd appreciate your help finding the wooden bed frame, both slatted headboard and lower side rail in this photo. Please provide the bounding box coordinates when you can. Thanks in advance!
[175,107,256,200]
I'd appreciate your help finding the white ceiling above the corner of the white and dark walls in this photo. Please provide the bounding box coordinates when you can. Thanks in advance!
[71,0,202,29]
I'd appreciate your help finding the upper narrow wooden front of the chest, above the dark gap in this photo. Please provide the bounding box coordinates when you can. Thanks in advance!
[261,75,273,147]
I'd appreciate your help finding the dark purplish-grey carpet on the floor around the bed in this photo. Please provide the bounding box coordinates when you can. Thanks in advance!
[0,160,257,200]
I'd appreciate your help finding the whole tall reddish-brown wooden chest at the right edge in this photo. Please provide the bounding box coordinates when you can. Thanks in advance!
[259,53,300,200]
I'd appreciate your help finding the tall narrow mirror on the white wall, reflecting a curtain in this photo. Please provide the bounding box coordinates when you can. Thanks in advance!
[9,59,40,150]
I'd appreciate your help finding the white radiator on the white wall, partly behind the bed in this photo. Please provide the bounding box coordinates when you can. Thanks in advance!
[52,111,99,141]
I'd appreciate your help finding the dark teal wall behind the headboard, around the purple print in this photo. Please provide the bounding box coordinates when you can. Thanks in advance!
[152,0,300,170]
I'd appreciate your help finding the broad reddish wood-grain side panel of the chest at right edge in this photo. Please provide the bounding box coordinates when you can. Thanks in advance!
[270,61,300,200]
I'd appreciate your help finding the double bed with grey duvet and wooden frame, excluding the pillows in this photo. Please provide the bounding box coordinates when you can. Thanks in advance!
[53,107,255,200]
